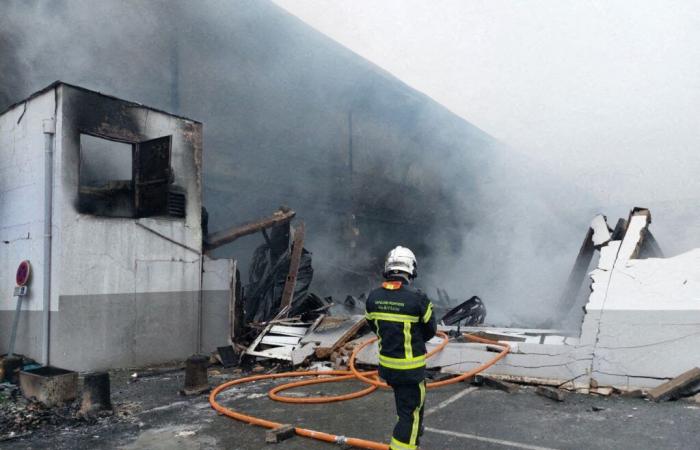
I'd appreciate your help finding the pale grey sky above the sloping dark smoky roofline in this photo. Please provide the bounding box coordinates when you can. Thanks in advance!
[275,0,700,207]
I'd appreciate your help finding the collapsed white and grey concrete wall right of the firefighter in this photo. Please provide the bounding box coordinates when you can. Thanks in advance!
[358,208,700,390]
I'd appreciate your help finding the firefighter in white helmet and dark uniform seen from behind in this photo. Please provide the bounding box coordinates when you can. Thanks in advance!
[365,246,437,450]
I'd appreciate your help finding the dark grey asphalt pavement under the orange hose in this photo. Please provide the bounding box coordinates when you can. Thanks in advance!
[0,372,700,450]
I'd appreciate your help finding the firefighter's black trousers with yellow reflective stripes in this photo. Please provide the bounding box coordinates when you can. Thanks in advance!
[390,381,425,450]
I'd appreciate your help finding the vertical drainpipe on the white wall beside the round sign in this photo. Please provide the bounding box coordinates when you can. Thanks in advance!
[41,118,56,366]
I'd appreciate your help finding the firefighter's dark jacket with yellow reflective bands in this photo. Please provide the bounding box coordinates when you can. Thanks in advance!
[365,280,437,384]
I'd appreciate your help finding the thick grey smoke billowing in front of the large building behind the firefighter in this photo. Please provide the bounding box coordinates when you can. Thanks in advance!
[0,0,608,325]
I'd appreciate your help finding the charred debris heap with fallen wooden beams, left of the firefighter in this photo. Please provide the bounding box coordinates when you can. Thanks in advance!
[211,207,364,366]
